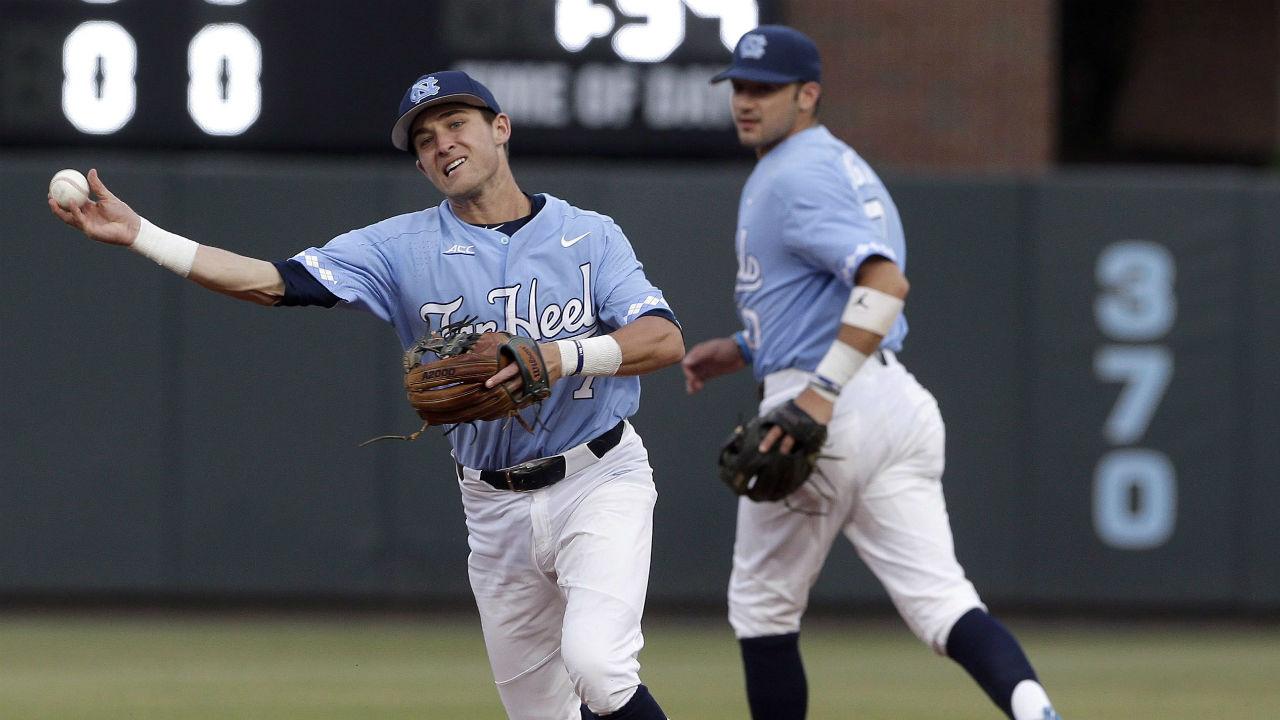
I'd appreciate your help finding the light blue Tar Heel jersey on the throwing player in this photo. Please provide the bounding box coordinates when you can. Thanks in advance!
[293,195,675,470]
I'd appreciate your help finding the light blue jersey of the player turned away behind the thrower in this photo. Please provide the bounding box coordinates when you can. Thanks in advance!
[735,126,906,380]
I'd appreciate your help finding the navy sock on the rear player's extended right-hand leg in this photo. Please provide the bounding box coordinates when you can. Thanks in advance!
[947,607,1039,717]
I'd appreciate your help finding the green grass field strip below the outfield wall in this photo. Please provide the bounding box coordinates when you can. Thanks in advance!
[0,612,1280,720]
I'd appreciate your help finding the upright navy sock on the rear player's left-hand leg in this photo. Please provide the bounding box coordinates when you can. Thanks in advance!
[739,633,809,720]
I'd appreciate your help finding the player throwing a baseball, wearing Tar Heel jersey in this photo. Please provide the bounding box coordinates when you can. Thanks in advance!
[49,70,684,720]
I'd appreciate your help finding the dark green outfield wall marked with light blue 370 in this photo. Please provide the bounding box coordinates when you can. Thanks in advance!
[0,154,1280,610]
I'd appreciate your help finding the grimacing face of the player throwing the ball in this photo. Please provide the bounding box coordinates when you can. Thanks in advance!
[410,104,511,199]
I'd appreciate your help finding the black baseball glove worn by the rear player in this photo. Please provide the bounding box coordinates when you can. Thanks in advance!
[719,400,827,502]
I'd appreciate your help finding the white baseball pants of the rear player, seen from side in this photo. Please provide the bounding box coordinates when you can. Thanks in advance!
[728,351,986,653]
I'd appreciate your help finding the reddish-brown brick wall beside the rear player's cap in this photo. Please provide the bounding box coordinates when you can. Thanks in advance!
[783,0,1057,172]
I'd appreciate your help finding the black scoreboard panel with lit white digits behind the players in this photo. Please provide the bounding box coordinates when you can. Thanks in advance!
[0,0,778,156]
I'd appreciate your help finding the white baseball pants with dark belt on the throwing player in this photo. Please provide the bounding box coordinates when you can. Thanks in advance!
[458,423,657,720]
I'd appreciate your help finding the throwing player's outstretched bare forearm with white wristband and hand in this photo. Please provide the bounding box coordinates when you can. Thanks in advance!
[49,169,284,305]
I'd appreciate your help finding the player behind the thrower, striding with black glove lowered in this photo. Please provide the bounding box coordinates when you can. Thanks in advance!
[684,26,1059,720]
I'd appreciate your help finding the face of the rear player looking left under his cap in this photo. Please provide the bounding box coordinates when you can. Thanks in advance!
[732,79,818,155]
